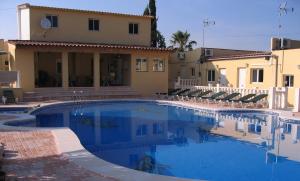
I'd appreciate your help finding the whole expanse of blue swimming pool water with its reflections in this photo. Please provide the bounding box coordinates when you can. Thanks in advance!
[6,101,300,181]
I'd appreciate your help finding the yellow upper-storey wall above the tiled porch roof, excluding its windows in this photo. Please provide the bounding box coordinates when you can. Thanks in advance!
[18,4,152,46]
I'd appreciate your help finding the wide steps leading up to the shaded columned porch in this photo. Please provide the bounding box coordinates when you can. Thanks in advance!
[23,87,140,102]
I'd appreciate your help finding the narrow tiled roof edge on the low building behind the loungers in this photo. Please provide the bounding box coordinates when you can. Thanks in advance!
[208,52,272,61]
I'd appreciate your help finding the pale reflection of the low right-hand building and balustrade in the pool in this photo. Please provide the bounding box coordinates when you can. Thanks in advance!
[211,114,300,161]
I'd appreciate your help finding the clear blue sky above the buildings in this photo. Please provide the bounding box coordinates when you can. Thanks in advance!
[0,0,300,50]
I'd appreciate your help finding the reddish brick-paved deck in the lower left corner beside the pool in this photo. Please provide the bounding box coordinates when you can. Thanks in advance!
[0,131,116,181]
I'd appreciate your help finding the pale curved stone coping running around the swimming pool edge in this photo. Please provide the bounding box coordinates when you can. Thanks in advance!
[0,99,300,181]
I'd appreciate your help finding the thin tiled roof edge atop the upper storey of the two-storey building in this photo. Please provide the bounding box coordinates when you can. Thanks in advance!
[18,3,153,19]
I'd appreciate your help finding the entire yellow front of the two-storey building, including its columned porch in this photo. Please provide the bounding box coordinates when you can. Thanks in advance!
[1,4,171,97]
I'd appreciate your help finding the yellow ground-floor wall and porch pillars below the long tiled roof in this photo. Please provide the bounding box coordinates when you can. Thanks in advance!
[9,44,169,96]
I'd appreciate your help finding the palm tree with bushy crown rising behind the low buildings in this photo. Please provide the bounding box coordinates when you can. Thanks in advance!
[171,31,197,51]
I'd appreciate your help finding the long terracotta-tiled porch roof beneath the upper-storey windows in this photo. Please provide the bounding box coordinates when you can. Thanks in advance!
[8,40,173,52]
